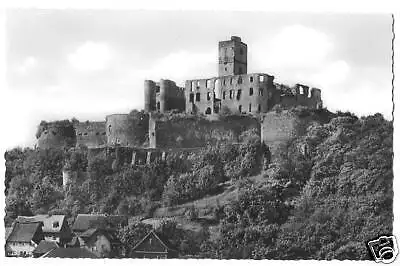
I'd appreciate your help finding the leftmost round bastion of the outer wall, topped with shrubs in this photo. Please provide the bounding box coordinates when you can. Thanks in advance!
[37,122,76,149]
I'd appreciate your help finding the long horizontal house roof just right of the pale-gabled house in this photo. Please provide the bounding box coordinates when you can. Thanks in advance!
[72,214,128,231]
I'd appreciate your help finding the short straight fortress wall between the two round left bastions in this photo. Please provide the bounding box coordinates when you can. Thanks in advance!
[74,121,107,148]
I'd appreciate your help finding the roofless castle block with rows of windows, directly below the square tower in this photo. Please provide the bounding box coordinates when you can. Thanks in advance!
[185,73,275,114]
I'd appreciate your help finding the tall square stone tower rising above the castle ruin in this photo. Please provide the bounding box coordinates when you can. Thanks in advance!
[218,36,247,77]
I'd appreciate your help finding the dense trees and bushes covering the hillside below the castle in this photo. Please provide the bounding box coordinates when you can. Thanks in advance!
[5,107,393,259]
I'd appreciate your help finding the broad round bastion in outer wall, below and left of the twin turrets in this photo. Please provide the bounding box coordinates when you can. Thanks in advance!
[106,113,149,147]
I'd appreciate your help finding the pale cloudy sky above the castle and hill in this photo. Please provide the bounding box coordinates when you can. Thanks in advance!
[4,9,392,146]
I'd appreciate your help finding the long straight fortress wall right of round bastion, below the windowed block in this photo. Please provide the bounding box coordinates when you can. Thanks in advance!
[154,116,260,148]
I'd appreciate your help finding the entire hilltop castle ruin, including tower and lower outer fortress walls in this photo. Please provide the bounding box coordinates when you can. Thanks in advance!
[37,36,322,163]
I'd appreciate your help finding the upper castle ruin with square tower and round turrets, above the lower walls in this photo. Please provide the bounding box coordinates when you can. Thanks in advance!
[144,36,322,115]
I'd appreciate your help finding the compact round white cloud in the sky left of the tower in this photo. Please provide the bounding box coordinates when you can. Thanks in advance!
[68,41,113,72]
